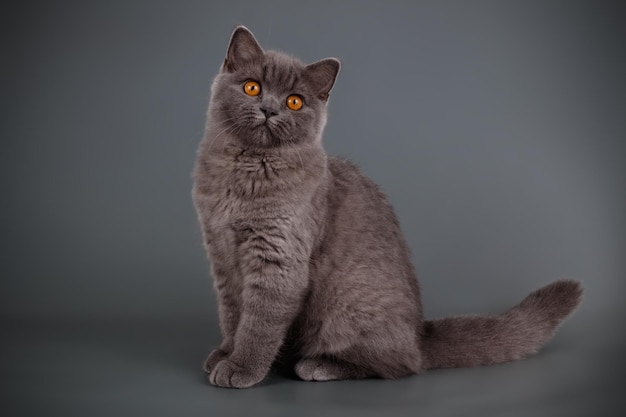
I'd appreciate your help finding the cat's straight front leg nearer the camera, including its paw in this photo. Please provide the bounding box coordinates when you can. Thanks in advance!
[210,245,307,388]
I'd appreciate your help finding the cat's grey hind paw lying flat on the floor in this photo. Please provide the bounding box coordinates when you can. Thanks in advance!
[295,356,370,381]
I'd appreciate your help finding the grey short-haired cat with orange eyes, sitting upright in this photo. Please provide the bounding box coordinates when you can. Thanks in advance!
[192,26,582,388]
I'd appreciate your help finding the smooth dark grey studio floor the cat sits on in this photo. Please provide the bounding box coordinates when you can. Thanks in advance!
[1,310,625,417]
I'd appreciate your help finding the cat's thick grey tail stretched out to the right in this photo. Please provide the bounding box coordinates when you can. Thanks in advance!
[421,280,582,369]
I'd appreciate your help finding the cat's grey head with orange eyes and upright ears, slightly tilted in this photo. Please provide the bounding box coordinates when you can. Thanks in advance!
[209,26,340,148]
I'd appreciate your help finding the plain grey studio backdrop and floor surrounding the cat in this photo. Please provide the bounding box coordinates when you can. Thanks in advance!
[0,0,626,416]
